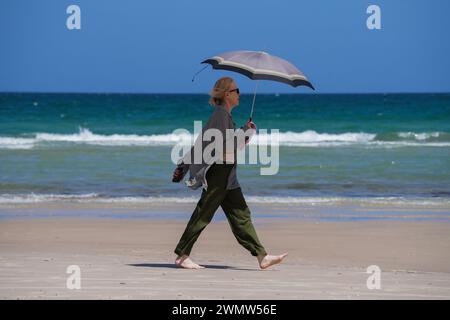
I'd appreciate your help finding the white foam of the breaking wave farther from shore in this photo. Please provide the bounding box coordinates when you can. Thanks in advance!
[0,128,450,149]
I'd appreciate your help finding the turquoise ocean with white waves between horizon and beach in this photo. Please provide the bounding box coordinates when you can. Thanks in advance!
[0,93,450,204]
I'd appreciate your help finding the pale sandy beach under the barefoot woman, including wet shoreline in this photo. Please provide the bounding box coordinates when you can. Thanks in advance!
[0,203,450,299]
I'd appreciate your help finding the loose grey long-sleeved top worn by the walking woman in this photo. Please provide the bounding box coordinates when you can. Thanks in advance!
[178,105,249,190]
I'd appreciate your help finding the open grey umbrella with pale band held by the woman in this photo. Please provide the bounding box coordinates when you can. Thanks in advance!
[194,51,314,120]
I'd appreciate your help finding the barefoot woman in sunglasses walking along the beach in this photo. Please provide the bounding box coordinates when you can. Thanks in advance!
[172,77,287,269]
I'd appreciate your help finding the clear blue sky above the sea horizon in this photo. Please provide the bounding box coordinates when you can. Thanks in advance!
[0,0,450,93]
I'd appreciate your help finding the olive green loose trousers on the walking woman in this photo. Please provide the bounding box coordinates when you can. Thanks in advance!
[175,163,266,256]
